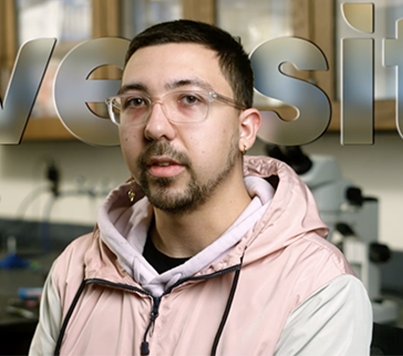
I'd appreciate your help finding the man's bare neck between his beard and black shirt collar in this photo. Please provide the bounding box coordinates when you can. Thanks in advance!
[150,174,251,258]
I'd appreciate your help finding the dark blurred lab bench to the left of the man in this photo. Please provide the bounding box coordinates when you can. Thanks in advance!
[0,219,93,356]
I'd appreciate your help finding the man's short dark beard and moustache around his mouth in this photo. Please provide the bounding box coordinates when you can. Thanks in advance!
[137,137,238,215]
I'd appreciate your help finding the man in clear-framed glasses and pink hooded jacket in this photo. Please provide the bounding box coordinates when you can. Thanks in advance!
[30,20,372,356]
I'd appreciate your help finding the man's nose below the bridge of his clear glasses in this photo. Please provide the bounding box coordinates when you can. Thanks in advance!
[144,102,175,141]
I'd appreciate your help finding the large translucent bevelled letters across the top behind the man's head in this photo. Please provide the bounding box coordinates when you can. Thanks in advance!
[0,3,403,146]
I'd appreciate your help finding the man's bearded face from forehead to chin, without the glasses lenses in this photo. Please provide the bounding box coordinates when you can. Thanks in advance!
[119,44,241,214]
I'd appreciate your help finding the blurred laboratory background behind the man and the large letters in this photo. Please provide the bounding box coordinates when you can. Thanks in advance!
[0,0,403,355]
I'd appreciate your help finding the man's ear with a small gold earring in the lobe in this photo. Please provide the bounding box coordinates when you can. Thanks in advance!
[239,108,262,152]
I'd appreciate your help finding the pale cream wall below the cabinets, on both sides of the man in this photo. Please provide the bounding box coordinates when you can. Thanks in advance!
[0,133,403,250]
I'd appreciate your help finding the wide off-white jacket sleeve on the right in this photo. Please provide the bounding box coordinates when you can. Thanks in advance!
[274,275,372,356]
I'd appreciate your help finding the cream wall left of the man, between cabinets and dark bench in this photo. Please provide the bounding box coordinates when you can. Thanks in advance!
[0,141,130,224]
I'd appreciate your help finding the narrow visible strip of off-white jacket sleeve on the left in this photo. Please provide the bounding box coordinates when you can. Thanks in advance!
[28,270,61,356]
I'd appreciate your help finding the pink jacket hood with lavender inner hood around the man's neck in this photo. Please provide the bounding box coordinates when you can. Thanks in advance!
[92,156,328,293]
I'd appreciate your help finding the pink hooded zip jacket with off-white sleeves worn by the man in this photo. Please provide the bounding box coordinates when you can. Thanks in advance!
[30,157,372,356]
